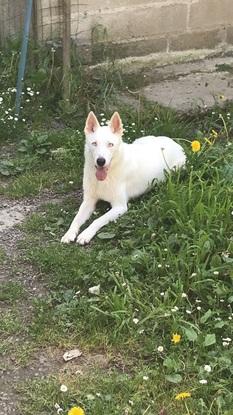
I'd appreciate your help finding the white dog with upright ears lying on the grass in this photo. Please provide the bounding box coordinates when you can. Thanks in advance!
[61,112,186,245]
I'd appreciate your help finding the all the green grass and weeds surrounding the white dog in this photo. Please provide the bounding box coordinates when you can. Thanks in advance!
[0,44,233,415]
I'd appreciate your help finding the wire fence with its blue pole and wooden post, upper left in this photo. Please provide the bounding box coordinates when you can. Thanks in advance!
[0,0,88,104]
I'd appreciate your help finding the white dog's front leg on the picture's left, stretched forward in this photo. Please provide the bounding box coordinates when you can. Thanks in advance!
[61,199,96,244]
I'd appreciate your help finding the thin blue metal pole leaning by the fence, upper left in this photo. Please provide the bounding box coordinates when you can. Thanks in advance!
[15,0,33,115]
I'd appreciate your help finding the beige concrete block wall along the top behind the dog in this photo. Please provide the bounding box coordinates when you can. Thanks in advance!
[66,0,233,61]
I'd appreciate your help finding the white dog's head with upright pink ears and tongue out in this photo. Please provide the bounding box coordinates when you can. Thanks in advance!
[84,112,123,180]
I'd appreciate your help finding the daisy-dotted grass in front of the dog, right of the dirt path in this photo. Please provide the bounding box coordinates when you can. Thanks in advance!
[8,108,233,415]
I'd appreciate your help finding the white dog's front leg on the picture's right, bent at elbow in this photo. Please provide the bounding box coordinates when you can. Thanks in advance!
[77,204,127,245]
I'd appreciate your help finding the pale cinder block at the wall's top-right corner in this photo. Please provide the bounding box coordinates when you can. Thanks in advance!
[189,0,233,30]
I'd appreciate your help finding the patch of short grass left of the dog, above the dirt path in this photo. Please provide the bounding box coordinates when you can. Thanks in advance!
[0,129,83,198]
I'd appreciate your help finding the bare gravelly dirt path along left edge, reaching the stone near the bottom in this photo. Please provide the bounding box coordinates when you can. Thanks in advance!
[0,194,109,415]
